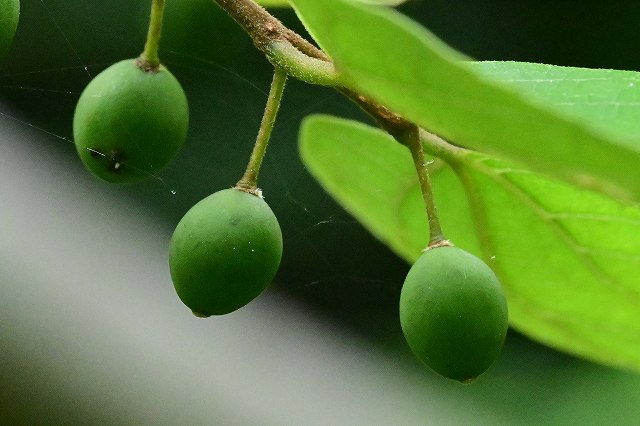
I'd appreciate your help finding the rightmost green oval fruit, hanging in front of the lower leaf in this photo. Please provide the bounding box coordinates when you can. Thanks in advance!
[400,246,508,382]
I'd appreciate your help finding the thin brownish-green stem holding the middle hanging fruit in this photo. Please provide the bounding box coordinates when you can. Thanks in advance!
[236,67,287,195]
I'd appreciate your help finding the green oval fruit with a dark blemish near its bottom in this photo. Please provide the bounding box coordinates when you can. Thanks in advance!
[73,59,189,183]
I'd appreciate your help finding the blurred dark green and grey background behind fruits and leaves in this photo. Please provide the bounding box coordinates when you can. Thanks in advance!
[0,0,640,425]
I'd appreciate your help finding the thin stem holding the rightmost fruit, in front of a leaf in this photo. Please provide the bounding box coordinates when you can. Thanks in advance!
[396,126,448,248]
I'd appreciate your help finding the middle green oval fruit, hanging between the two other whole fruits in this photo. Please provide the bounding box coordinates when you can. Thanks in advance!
[169,188,282,317]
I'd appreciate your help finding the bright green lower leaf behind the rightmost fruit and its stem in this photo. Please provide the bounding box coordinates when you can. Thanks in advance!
[300,116,640,370]
